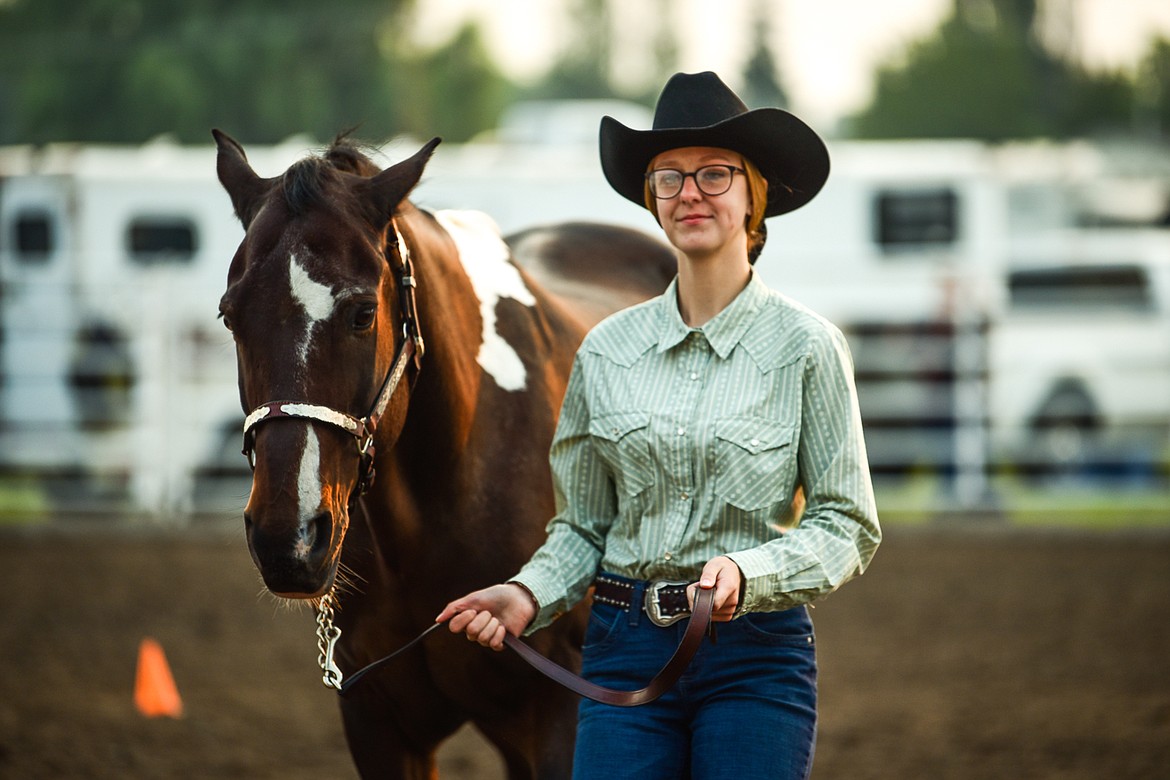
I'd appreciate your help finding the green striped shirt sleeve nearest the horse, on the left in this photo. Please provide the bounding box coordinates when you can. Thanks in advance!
[512,354,618,633]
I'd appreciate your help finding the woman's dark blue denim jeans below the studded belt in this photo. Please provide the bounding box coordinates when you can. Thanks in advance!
[573,589,817,780]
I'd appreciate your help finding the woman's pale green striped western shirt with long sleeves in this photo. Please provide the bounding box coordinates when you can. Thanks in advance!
[514,274,881,630]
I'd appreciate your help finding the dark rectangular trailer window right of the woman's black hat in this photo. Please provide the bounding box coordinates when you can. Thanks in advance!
[875,187,958,250]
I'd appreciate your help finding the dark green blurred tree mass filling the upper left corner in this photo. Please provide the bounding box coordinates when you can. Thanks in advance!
[0,0,421,143]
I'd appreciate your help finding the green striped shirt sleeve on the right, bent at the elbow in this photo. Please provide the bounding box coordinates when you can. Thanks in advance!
[728,327,881,614]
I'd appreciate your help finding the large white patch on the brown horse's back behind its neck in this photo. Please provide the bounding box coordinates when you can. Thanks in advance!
[435,210,536,391]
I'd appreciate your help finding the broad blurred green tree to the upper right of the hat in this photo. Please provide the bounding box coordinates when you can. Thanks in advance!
[852,0,1131,140]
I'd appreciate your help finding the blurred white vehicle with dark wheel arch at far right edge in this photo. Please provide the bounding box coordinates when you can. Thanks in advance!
[987,228,1170,478]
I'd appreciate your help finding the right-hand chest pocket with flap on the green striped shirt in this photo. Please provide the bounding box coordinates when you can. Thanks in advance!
[715,415,796,511]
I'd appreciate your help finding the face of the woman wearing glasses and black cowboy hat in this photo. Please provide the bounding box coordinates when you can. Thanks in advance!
[651,146,751,264]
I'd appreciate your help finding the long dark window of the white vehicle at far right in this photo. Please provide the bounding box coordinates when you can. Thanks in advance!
[1007,264,1154,311]
